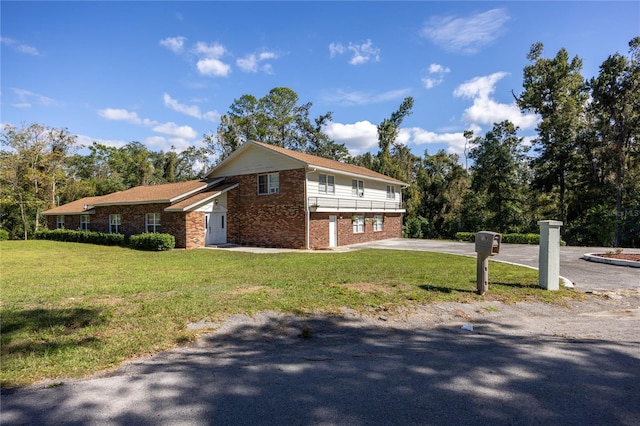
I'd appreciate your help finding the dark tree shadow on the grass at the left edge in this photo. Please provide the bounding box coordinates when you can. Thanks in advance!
[0,308,106,358]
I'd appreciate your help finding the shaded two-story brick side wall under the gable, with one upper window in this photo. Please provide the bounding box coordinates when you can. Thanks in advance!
[226,168,306,248]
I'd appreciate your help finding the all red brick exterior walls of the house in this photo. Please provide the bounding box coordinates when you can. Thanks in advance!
[47,168,402,249]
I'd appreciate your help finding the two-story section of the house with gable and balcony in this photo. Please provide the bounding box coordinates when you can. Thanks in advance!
[208,142,407,249]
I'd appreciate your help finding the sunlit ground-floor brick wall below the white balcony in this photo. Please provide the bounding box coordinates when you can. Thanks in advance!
[309,213,402,249]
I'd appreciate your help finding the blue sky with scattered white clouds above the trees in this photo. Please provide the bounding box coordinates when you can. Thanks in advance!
[0,1,640,161]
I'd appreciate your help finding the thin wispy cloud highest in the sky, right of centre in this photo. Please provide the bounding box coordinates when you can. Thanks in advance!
[422,9,509,53]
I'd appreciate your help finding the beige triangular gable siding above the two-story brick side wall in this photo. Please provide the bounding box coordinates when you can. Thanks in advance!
[214,147,303,177]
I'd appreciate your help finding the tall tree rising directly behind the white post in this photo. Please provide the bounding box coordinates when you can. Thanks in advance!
[516,43,588,224]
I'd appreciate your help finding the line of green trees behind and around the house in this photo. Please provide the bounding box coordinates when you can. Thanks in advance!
[0,37,640,247]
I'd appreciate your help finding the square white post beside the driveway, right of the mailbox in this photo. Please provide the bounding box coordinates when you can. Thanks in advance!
[538,220,562,290]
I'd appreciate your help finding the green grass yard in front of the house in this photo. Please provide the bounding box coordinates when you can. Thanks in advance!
[0,241,580,387]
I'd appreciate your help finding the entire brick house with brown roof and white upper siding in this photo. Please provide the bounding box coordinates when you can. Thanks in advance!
[43,141,407,249]
